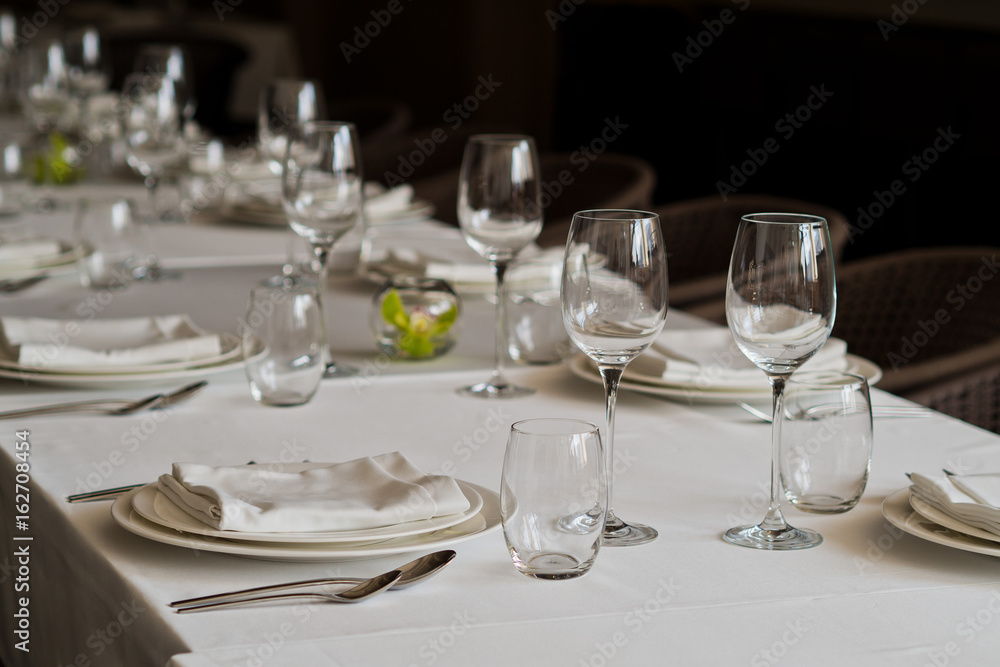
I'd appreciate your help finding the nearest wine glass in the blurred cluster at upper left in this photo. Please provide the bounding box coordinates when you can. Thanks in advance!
[122,73,185,280]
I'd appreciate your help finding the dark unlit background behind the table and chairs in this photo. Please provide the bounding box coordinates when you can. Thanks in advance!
[13,0,1000,259]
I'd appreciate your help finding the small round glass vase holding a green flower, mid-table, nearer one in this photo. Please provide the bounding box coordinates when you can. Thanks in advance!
[369,276,462,360]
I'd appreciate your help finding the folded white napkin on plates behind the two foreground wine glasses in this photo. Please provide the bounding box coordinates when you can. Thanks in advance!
[625,327,848,391]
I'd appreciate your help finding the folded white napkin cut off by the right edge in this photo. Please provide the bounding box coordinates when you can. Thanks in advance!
[910,473,1000,535]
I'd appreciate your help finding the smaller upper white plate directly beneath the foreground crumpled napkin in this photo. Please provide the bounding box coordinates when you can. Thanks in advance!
[132,482,483,544]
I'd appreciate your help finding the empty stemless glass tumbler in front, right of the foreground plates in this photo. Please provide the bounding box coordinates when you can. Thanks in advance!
[500,419,608,579]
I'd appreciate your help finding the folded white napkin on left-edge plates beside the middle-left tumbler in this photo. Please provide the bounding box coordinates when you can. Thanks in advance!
[0,315,222,370]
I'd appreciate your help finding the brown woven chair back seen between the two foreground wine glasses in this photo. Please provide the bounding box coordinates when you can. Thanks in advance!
[653,194,849,310]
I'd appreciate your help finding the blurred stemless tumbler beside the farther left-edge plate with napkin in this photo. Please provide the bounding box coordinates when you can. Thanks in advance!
[74,197,142,290]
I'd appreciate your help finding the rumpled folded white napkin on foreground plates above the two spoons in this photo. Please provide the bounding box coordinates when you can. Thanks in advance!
[158,452,469,533]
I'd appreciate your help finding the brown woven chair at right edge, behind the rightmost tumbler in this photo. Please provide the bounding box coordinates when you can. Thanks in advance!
[833,247,1000,398]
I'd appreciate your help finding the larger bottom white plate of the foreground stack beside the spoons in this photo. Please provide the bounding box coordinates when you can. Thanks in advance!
[111,484,500,562]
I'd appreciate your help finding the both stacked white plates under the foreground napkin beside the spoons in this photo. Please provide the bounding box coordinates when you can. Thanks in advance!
[111,480,500,561]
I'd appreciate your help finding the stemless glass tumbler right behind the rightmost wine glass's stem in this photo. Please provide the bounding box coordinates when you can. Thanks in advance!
[780,371,872,514]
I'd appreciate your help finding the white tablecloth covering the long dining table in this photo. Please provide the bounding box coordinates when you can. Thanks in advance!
[0,210,1000,667]
